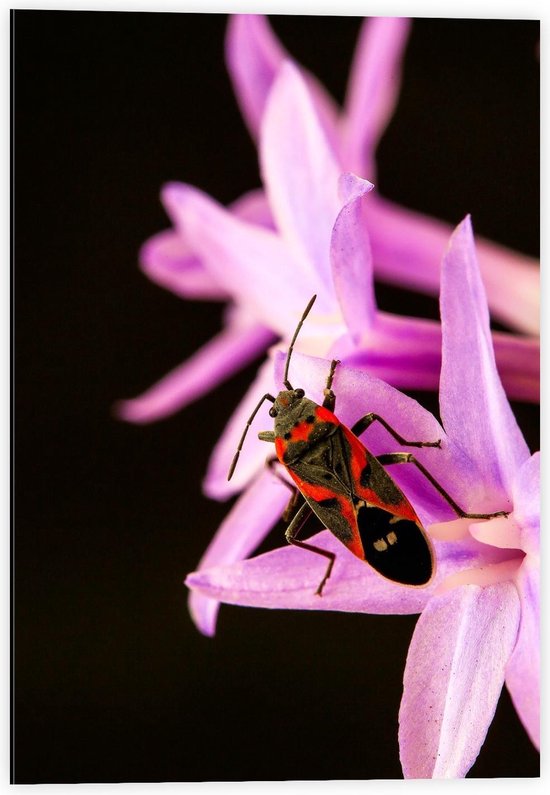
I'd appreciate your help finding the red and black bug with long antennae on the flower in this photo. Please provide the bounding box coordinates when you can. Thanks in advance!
[228,296,507,596]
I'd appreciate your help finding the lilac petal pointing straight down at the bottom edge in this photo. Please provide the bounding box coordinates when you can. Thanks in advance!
[399,582,520,778]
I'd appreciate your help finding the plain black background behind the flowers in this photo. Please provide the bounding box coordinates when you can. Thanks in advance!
[13,11,539,783]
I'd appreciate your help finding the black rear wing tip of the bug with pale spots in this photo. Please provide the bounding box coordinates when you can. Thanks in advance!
[357,506,433,585]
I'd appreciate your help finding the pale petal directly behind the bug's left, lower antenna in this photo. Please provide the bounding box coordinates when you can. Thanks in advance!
[203,359,275,500]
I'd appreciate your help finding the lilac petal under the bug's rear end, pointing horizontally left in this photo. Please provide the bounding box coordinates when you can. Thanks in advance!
[186,532,516,615]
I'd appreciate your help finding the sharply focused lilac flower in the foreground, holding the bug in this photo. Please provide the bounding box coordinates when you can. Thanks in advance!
[187,219,540,778]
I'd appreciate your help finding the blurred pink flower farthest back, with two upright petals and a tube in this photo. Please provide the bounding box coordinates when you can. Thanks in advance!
[226,14,539,334]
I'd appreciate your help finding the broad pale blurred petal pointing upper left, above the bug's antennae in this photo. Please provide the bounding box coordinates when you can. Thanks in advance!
[163,183,327,336]
